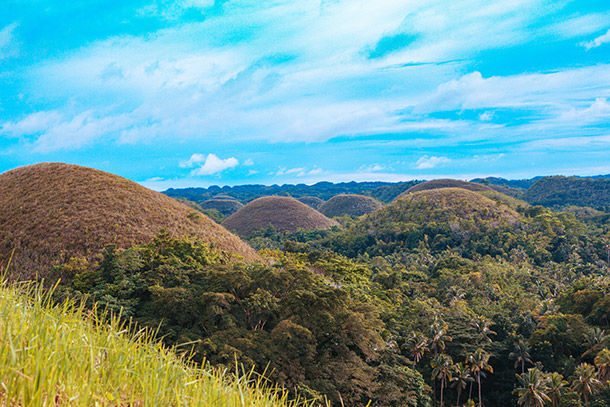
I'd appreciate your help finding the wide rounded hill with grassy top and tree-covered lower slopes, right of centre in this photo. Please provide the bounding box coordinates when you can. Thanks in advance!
[329,188,523,257]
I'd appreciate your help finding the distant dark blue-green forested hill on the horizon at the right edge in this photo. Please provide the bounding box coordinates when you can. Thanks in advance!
[525,176,610,211]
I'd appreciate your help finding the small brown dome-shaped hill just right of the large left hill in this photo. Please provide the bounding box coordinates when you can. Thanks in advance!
[222,196,338,237]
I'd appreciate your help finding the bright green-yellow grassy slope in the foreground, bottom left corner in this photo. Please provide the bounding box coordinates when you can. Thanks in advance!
[0,284,314,407]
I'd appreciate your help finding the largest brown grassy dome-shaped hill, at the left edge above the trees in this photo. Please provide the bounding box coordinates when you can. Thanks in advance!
[0,163,258,278]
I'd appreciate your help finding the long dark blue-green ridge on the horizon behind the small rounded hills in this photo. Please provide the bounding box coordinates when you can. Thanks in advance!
[163,181,421,204]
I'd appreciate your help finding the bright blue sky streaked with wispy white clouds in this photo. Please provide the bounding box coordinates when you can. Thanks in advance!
[0,0,610,190]
